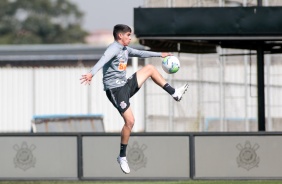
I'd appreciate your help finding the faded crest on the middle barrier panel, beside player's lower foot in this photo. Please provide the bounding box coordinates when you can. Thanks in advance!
[127,141,147,171]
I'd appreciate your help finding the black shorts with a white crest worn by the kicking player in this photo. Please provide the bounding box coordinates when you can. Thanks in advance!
[106,73,140,114]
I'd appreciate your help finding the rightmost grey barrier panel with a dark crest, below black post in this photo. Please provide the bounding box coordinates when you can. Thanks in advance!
[195,135,282,179]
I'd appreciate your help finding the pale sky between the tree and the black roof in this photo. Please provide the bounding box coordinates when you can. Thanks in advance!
[70,0,144,32]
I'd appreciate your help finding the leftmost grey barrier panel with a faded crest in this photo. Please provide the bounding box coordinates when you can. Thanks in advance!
[0,136,78,180]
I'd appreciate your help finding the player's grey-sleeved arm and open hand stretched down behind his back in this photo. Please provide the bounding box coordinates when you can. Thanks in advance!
[80,46,118,85]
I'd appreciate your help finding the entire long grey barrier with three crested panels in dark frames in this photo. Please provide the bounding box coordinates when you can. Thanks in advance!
[0,132,282,180]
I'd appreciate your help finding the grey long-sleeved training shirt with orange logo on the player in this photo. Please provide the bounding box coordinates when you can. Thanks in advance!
[91,41,161,90]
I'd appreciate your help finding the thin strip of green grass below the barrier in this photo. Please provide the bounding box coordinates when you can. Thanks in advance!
[0,180,282,184]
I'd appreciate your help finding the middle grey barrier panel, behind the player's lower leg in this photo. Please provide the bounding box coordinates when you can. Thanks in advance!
[82,135,190,179]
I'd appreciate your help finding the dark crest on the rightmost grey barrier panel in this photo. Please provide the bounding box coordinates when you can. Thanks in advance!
[236,141,260,171]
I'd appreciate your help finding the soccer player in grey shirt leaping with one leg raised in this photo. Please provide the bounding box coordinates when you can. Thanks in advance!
[80,24,188,174]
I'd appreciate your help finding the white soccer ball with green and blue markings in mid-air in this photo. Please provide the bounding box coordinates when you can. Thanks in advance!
[162,56,180,74]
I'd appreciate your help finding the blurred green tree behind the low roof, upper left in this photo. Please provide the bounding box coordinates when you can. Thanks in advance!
[0,0,87,44]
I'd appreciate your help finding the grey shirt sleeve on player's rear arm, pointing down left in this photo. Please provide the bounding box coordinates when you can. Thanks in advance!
[90,47,118,76]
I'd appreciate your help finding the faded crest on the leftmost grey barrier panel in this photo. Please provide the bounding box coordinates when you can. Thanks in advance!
[13,142,36,171]
